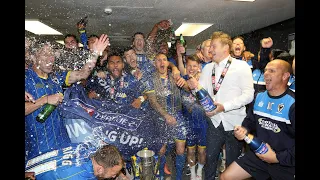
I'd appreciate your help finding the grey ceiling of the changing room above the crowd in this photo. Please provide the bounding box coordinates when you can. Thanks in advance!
[25,0,295,49]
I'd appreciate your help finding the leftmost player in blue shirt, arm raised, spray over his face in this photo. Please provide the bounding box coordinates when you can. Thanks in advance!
[25,34,109,172]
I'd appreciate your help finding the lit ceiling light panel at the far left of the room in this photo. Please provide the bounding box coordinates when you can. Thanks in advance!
[25,20,62,35]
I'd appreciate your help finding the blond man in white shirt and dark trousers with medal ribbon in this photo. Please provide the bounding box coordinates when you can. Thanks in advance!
[187,31,254,180]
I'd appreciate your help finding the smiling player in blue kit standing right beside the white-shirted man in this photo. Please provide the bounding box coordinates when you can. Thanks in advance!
[181,54,213,180]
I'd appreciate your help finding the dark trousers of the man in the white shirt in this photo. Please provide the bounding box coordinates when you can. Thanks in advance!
[204,122,243,180]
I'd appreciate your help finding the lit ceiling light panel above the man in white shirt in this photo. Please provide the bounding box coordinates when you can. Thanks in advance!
[174,23,213,36]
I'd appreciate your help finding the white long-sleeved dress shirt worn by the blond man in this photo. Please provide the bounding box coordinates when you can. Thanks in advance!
[199,55,254,131]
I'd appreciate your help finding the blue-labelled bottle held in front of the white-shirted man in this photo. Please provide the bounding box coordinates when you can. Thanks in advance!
[195,87,217,112]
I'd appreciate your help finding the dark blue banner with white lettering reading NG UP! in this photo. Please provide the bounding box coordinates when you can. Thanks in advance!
[58,85,163,158]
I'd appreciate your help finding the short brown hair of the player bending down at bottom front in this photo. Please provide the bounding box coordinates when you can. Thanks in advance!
[91,144,124,168]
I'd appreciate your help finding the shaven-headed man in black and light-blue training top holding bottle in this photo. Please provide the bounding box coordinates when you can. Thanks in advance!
[220,59,295,180]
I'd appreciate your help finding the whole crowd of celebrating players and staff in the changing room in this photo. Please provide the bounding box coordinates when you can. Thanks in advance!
[25,20,295,180]
